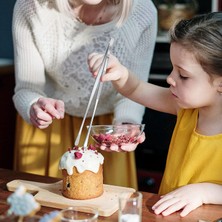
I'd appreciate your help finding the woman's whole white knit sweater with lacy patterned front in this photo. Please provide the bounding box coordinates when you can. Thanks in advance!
[13,0,157,123]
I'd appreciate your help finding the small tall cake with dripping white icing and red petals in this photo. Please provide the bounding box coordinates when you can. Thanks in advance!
[59,145,104,200]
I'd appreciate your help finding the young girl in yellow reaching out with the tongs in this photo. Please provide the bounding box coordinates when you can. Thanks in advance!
[89,12,222,217]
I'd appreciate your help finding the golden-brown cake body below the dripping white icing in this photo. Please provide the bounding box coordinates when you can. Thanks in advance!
[62,165,103,200]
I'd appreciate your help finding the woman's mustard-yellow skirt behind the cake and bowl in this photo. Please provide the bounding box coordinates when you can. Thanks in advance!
[14,114,137,189]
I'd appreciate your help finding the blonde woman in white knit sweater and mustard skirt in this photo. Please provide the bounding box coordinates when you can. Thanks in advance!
[13,0,157,188]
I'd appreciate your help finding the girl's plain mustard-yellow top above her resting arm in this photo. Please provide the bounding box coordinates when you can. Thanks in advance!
[159,109,222,195]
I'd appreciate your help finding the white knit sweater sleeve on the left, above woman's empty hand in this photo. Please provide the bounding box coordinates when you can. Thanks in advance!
[12,0,45,123]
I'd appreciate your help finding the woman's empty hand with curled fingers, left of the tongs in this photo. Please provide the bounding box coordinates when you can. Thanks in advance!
[30,97,65,129]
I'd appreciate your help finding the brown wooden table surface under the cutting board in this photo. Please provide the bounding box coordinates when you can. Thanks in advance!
[0,168,222,222]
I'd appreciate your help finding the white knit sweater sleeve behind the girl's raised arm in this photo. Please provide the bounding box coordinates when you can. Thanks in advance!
[114,0,157,123]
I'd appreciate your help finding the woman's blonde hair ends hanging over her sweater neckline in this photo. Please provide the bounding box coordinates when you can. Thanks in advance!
[55,0,133,27]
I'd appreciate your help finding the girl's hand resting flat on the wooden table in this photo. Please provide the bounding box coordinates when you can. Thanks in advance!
[152,183,205,217]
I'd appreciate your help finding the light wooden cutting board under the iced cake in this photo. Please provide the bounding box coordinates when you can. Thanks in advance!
[7,180,135,217]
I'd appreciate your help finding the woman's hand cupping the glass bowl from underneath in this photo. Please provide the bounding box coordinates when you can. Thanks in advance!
[100,133,146,152]
